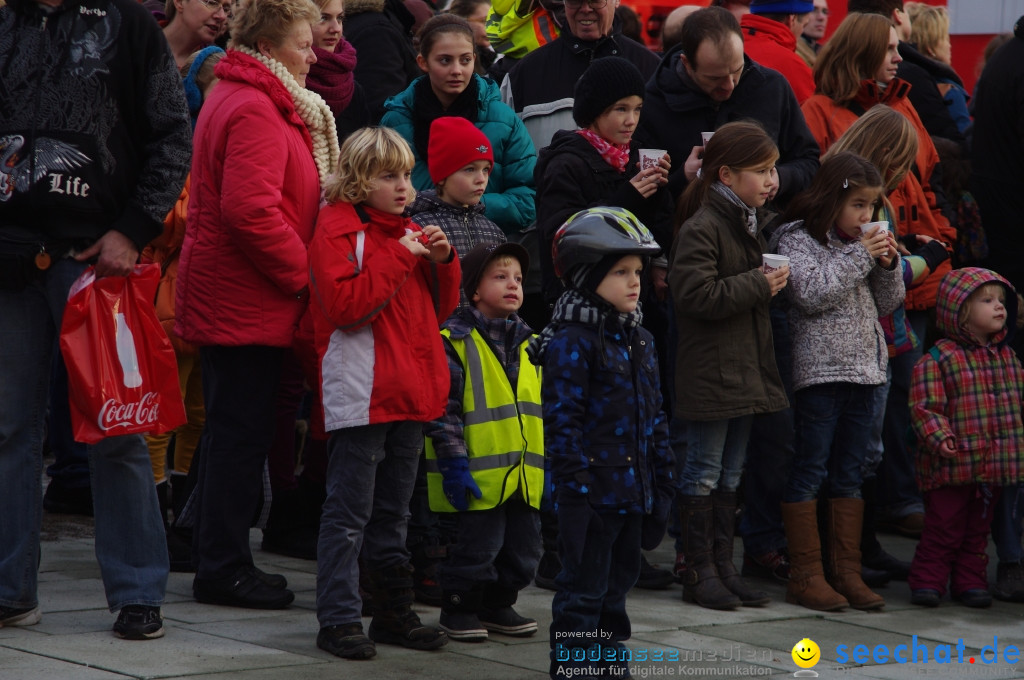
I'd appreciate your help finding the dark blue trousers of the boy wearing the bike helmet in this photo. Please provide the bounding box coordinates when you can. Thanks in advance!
[550,499,642,678]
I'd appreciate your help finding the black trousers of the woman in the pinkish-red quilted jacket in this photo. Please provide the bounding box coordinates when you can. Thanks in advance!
[193,345,285,579]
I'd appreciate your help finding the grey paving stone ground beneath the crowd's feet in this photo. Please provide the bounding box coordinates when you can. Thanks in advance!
[0,516,1024,680]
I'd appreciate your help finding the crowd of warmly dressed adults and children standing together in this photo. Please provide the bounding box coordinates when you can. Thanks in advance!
[0,0,1024,678]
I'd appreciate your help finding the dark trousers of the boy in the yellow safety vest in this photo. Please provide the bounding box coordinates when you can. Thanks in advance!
[440,499,541,592]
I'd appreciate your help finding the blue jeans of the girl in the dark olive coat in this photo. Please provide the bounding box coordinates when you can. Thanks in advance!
[679,416,754,496]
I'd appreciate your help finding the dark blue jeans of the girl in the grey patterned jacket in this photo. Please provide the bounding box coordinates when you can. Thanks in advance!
[783,383,879,503]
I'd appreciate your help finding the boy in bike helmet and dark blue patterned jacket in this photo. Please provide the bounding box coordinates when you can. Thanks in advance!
[528,208,675,678]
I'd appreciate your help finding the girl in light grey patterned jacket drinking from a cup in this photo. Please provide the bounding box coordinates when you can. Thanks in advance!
[770,151,905,611]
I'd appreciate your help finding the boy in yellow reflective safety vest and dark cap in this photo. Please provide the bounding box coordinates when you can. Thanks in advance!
[424,243,545,642]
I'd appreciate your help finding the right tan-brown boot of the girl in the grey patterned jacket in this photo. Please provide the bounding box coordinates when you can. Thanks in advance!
[827,498,886,609]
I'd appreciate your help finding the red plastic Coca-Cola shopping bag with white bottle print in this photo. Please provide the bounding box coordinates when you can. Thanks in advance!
[60,264,185,443]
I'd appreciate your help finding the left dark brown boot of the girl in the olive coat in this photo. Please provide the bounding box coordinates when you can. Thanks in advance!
[679,496,742,609]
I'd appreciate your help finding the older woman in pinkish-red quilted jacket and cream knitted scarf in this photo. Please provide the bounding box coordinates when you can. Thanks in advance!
[175,0,339,609]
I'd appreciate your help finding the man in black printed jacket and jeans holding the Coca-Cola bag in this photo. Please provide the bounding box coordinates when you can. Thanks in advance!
[0,0,190,640]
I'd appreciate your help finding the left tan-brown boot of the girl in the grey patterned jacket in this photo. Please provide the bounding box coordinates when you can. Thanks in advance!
[782,501,850,611]
